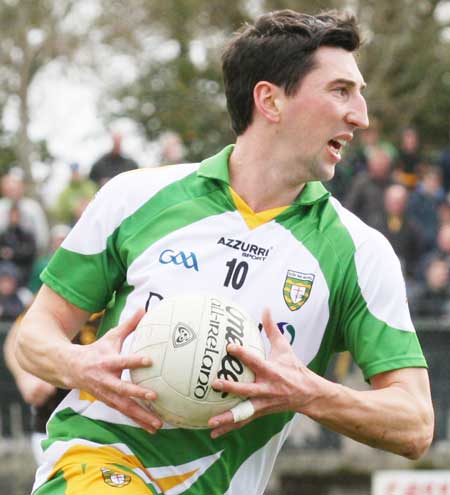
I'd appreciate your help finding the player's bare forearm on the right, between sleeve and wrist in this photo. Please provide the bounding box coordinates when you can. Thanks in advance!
[301,370,434,459]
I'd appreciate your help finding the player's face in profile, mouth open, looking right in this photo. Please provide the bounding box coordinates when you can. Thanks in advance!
[279,47,369,182]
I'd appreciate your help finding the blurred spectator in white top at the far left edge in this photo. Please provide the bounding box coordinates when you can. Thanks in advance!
[0,168,50,253]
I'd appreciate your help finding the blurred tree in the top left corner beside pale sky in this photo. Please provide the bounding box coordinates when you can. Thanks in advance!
[0,0,90,181]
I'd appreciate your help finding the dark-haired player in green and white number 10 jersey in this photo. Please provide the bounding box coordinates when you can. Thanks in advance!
[17,11,433,495]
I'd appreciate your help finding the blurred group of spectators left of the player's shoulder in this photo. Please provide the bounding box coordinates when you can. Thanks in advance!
[0,134,138,321]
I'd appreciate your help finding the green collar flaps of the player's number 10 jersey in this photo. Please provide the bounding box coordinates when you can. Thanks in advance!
[197,144,330,205]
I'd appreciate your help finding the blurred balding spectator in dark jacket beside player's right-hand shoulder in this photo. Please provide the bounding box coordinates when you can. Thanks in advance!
[374,184,424,283]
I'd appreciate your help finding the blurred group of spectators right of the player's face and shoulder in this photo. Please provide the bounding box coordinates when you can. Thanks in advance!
[329,122,450,318]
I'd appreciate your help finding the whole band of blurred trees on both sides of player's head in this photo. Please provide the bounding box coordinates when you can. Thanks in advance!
[0,0,450,169]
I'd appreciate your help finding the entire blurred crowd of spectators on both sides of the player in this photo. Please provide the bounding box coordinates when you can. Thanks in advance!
[0,122,450,321]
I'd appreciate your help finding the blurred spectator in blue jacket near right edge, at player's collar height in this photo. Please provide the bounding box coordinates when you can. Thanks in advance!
[408,167,445,250]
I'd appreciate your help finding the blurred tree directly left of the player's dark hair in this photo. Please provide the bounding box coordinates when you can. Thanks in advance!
[95,0,250,160]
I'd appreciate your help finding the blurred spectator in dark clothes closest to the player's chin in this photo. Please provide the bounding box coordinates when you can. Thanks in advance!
[344,147,392,227]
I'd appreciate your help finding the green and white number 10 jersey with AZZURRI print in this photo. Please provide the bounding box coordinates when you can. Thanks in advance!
[35,146,426,495]
